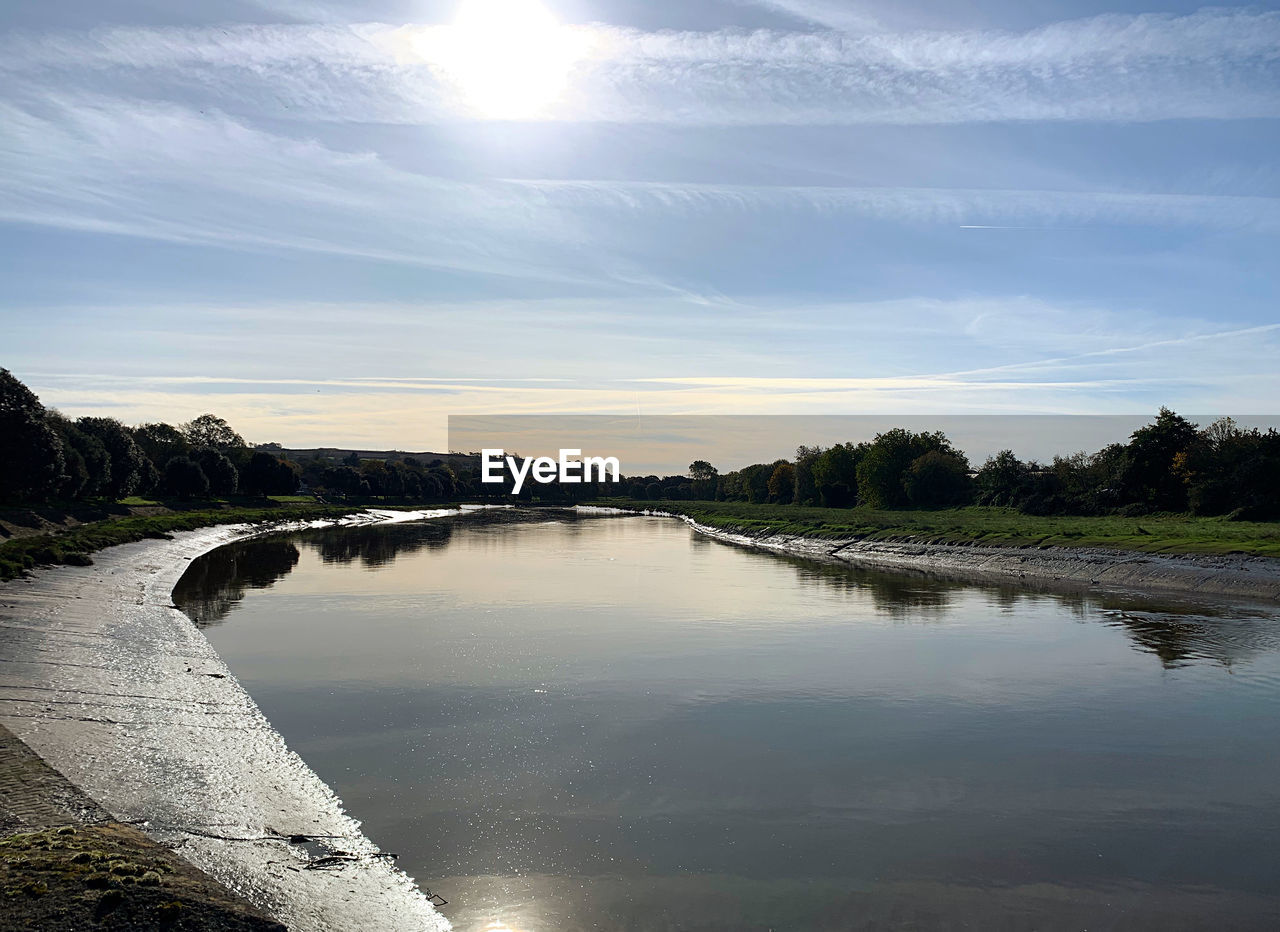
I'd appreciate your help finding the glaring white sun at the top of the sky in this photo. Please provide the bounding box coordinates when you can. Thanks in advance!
[433,0,581,119]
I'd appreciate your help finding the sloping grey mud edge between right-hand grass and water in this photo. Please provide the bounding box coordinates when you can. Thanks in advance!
[593,508,1280,602]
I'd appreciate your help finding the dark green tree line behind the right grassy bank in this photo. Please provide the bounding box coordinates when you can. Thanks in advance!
[609,408,1280,520]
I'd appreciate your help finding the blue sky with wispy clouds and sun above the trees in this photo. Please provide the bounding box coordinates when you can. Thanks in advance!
[0,0,1280,449]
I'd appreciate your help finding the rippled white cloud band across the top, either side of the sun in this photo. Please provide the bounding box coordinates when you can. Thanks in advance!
[0,9,1280,124]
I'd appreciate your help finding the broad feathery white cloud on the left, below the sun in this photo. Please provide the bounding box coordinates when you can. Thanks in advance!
[0,95,622,282]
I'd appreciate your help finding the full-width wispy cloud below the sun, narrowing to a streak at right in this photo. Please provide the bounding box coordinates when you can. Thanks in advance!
[0,95,1280,288]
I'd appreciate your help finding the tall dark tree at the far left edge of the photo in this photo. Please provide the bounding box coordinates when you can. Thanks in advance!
[0,369,64,502]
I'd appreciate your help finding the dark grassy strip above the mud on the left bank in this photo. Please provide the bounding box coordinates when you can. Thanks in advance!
[0,503,358,580]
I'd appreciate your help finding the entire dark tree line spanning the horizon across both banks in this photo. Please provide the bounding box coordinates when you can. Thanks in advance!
[0,369,1280,520]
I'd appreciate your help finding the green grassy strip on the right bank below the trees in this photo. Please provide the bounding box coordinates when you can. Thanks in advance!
[598,499,1280,557]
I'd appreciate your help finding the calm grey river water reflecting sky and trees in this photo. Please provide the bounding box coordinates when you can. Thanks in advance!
[178,513,1280,932]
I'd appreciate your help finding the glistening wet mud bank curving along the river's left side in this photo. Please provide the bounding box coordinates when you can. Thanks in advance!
[0,512,449,932]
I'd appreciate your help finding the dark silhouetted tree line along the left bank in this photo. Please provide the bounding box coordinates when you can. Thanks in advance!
[0,369,474,504]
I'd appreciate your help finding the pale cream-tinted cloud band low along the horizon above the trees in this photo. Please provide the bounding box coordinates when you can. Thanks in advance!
[29,366,1280,452]
